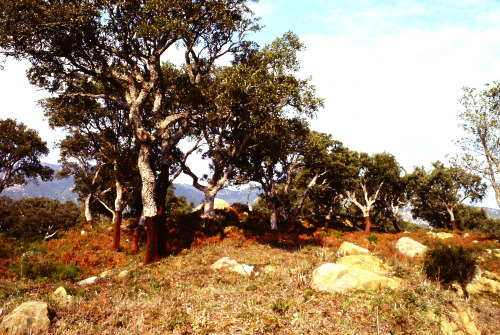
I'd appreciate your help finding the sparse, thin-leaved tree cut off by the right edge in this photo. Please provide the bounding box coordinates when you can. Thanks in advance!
[453,82,500,206]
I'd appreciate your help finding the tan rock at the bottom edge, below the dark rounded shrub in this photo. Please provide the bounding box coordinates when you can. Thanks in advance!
[428,301,481,335]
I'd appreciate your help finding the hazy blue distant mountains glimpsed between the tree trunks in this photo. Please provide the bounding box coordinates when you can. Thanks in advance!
[2,163,259,206]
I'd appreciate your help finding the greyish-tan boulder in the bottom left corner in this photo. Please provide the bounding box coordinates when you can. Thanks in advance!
[0,301,50,335]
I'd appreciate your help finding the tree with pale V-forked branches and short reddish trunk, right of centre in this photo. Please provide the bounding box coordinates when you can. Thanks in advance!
[345,153,402,234]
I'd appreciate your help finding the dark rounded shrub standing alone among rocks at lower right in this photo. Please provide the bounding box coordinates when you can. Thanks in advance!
[424,244,477,299]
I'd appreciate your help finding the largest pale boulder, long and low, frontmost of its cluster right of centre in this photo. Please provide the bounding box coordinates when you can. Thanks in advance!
[311,263,400,293]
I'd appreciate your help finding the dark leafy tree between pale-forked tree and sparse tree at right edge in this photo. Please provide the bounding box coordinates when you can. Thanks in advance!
[411,161,487,230]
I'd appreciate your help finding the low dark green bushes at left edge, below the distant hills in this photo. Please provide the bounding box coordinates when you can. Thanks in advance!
[0,197,84,241]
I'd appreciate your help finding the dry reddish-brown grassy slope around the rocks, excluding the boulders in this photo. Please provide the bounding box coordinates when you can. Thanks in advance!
[0,217,500,334]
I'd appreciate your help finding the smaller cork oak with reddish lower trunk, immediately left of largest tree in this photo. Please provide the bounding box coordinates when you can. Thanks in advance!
[43,93,138,250]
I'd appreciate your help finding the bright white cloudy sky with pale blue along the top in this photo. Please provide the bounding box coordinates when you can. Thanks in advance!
[0,0,500,207]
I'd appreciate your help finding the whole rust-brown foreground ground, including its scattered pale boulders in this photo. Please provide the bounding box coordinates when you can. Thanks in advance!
[0,217,500,334]
